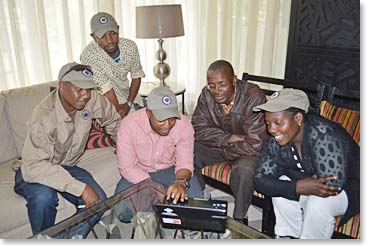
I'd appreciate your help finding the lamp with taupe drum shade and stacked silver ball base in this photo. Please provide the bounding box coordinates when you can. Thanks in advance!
[136,4,185,86]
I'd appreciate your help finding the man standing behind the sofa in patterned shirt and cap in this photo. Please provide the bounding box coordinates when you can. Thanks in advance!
[80,12,145,118]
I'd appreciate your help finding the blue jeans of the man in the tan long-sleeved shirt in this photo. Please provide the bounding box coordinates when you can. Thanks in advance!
[14,166,107,238]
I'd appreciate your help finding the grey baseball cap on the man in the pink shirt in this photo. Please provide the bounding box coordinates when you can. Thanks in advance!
[147,86,180,121]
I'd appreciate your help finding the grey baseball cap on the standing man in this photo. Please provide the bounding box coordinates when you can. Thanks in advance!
[90,12,119,38]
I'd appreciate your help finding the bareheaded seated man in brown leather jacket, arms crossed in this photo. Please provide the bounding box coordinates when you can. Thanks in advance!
[192,60,267,223]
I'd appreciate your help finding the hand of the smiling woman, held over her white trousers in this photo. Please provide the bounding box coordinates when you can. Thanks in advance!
[296,175,341,197]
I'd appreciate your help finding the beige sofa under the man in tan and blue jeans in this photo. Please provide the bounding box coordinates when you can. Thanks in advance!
[0,82,120,239]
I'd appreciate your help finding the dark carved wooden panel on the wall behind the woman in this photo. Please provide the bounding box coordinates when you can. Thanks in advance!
[285,0,360,93]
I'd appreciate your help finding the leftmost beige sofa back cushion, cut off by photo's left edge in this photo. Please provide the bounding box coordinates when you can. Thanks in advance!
[0,93,18,163]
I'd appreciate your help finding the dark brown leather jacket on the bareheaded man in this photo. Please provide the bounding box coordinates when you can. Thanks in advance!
[191,80,267,160]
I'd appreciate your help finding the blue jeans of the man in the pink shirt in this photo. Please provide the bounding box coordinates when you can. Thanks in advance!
[115,166,204,198]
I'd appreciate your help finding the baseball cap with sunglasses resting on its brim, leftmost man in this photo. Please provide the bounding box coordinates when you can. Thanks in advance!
[58,62,98,89]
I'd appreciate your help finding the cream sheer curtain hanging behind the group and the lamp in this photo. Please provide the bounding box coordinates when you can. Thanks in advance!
[0,0,291,114]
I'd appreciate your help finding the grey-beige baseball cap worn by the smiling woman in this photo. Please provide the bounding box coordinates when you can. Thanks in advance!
[253,88,310,113]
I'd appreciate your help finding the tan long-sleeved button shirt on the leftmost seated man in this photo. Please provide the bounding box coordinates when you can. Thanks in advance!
[21,90,121,196]
